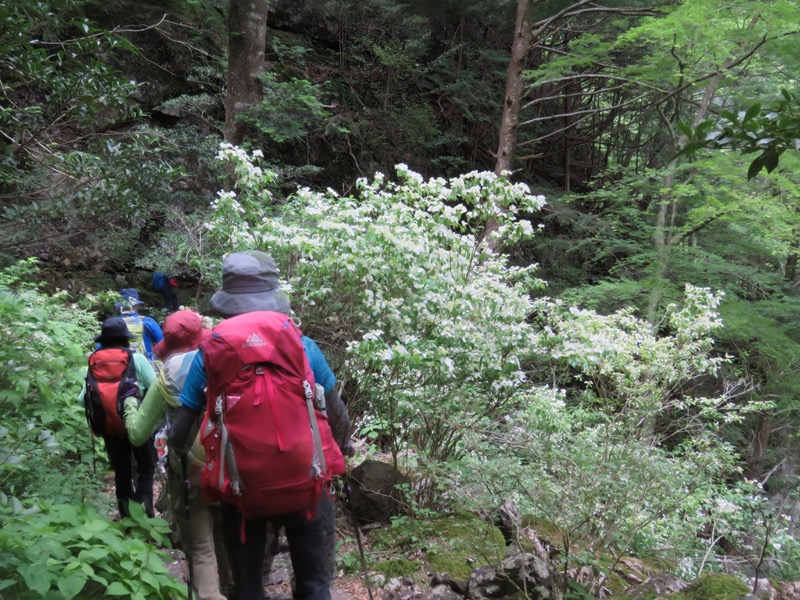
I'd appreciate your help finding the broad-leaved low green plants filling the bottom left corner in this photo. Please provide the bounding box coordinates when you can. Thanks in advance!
[0,503,185,600]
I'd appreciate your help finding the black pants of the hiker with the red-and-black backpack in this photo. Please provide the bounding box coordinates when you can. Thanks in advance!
[105,437,156,517]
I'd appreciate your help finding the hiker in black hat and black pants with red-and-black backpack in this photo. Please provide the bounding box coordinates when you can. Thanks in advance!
[79,317,156,517]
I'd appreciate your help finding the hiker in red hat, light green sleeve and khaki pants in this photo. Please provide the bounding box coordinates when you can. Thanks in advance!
[124,310,234,600]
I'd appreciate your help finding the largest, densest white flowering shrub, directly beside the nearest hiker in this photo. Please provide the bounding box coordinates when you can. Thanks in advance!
[203,148,544,459]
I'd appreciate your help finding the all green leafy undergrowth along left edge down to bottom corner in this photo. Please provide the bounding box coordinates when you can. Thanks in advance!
[0,260,183,600]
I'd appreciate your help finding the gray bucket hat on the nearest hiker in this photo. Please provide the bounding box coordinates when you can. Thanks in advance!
[211,250,291,317]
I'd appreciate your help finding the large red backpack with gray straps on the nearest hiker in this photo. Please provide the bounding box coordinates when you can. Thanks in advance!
[200,311,344,517]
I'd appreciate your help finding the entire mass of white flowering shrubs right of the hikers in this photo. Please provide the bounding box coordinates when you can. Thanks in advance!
[202,147,788,570]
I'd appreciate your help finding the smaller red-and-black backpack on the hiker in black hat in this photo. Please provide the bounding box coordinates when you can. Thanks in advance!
[83,348,141,438]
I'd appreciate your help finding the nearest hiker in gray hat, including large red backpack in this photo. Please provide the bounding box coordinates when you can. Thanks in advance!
[169,251,349,600]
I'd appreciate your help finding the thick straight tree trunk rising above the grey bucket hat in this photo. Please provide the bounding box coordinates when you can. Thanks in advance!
[225,0,268,144]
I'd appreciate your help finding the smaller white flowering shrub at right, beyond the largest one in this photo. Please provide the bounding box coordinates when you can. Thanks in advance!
[534,285,767,432]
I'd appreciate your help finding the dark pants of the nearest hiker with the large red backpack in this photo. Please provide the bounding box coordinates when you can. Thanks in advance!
[222,496,333,600]
